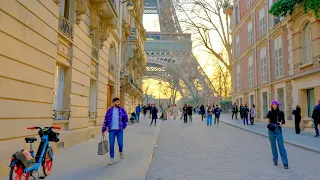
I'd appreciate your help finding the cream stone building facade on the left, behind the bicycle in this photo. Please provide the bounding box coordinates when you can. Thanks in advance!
[0,0,146,178]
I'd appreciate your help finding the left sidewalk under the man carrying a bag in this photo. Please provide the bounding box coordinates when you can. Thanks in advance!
[2,117,161,180]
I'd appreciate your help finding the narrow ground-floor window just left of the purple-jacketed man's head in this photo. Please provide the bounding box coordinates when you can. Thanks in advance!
[89,79,98,119]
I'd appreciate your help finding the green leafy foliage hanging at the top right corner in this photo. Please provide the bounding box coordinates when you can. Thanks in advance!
[269,0,320,19]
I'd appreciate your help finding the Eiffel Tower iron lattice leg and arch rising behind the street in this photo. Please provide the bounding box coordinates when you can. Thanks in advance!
[144,0,217,102]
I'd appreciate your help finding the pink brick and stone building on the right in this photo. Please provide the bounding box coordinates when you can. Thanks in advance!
[224,0,320,130]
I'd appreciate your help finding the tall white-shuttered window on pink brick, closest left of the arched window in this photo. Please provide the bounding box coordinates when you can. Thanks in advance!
[274,36,283,79]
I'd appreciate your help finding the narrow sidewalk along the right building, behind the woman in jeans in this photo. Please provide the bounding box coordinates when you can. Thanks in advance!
[220,114,320,153]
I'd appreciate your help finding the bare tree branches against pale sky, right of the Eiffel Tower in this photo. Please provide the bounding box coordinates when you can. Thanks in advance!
[176,0,232,73]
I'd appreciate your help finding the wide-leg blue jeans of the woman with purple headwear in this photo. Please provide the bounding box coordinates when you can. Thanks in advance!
[268,126,288,165]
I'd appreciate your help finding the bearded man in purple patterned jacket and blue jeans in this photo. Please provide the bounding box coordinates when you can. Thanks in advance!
[102,98,128,165]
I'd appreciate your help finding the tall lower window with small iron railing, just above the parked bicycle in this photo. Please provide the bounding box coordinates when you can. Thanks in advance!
[53,65,65,120]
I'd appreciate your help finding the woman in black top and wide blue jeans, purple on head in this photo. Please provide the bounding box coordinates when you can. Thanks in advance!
[267,100,289,169]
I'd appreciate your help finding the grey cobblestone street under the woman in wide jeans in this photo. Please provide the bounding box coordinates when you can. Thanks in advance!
[147,115,320,180]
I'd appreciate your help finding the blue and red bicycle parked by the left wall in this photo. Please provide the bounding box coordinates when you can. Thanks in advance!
[9,126,61,180]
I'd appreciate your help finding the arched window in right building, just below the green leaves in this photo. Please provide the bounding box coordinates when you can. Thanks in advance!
[302,22,312,64]
